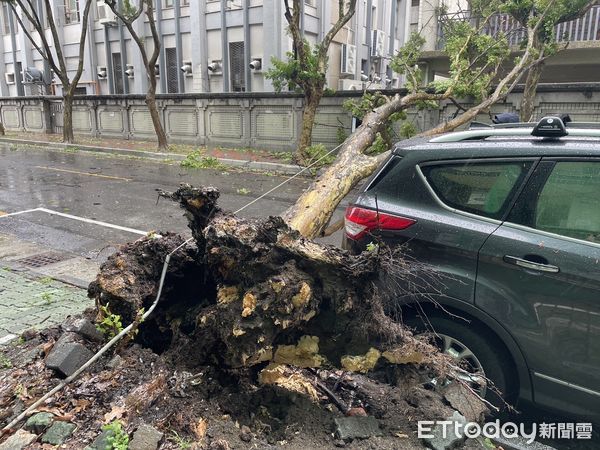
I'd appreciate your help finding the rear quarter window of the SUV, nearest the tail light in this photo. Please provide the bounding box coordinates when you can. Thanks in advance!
[422,161,532,219]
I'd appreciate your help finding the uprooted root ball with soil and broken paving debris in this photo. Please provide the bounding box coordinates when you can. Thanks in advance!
[0,186,492,450]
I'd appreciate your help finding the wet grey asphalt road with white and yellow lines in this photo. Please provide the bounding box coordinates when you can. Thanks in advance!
[0,146,343,256]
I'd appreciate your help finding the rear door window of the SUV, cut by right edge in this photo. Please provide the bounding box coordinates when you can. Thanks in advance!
[533,161,600,243]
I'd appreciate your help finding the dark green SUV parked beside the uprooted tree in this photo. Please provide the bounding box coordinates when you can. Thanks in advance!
[344,117,600,422]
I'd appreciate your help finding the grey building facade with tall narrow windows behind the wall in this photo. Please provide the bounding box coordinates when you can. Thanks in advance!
[0,0,420,97]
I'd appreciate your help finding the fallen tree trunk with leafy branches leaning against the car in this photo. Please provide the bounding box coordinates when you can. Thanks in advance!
[283,0,558,238]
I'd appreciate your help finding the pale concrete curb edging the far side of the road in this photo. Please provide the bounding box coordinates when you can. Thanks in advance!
[0,137,310,176]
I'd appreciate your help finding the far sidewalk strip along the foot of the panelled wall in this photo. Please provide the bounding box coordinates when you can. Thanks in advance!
[0,132,302,175]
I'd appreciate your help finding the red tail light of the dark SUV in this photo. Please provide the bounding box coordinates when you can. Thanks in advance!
[344,206,416,240]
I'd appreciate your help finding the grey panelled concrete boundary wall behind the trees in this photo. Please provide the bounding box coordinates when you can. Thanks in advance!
[0,83,600,151]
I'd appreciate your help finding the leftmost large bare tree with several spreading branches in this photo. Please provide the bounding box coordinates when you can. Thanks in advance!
[0,0,92,144]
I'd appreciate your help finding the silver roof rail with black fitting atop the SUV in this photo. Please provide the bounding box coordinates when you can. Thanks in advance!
[429,116,600,143]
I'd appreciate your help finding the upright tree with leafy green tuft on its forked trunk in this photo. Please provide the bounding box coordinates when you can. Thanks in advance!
[267,0,356,163]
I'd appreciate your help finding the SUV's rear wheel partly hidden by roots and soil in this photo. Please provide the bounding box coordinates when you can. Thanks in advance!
[406,316,516,409]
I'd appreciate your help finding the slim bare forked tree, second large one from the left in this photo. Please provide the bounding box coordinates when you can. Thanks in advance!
[105,0,169,151]
